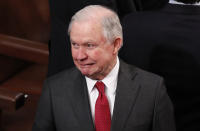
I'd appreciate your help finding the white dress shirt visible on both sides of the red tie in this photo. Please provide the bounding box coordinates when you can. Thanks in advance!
[85,57,119,120]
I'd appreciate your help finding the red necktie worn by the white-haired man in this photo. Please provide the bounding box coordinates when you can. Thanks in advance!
[95,81,111,131]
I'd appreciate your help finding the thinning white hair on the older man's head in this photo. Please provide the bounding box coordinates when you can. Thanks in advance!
[68,5,123,43]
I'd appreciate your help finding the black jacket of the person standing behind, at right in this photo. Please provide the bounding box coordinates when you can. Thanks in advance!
[120,4,200,131]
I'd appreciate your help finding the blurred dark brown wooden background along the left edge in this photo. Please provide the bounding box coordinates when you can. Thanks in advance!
[0,0,50,131]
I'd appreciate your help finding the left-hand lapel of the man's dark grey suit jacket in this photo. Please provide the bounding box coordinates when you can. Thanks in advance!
[67,73,94,131]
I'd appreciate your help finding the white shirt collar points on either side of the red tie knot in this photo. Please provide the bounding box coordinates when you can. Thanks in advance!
[85,57,119,93]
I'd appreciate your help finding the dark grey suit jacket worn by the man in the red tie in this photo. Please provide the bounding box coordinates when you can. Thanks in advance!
[33,62,175,131]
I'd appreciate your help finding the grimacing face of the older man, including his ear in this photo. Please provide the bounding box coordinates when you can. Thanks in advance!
[70,21,117,79]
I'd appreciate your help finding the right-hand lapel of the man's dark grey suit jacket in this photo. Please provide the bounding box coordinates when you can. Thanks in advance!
[111,61,140,131]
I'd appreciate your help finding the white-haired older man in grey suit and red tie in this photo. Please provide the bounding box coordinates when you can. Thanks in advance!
[33,5,175,131]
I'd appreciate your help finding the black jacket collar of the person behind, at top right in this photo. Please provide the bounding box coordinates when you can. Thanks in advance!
[161,4,200,15]
